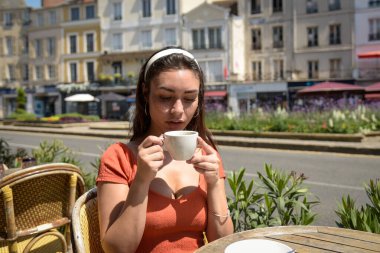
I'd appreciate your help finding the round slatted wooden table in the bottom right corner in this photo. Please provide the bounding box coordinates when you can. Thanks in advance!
[195,226,380,253]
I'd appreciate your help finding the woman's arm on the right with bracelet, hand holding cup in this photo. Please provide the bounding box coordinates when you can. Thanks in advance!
[190,137,233,241]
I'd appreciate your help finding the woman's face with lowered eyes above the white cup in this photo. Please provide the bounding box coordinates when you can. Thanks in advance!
[148,69,200,136]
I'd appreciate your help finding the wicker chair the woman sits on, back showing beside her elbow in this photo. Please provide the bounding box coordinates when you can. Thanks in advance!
[72,187,104,253]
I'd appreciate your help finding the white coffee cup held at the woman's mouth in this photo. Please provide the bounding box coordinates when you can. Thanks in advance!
[164,130,198,161]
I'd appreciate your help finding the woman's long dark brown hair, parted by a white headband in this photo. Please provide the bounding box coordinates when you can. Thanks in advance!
[131,47,216,149]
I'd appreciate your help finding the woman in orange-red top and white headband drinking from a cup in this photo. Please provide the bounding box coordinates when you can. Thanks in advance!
[97,48,233,253]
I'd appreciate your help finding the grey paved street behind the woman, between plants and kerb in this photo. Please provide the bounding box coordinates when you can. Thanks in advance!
[0,131,380,226]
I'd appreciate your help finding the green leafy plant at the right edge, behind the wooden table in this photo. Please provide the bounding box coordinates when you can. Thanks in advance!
[335,179,380,234]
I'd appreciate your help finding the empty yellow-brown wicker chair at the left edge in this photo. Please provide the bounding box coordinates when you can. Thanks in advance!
[0,163,84,253]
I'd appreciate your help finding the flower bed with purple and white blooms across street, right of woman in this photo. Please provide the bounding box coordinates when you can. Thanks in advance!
[206,106,380,134]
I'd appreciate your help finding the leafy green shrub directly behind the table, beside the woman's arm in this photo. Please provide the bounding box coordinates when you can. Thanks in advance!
[227,164,319,231]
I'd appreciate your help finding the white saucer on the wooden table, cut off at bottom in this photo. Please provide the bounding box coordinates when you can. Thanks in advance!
[224,239,294,253]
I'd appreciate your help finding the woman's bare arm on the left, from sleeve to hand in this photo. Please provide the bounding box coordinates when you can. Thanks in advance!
[98,136,164,253]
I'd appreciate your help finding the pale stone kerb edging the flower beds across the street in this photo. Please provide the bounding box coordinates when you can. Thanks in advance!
[0,122,380,156]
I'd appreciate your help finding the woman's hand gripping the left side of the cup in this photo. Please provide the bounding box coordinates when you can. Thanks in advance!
[136,135,165,183]
